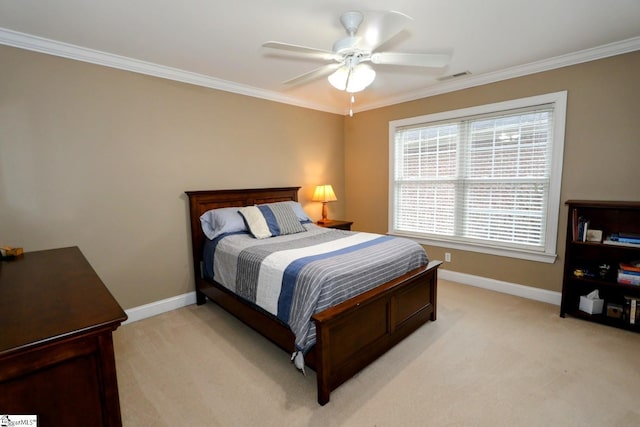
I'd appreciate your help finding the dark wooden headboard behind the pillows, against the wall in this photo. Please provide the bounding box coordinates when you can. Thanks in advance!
[185,187,300,280]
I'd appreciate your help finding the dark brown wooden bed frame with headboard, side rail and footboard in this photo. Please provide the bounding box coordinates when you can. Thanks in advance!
[186,187,441,405]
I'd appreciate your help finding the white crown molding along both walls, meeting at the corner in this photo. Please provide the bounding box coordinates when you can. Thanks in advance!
[0,27,640,115]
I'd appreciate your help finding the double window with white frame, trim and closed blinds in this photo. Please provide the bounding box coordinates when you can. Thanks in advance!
[389,92,567,262]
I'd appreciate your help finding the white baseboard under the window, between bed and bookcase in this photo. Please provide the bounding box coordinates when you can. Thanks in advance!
[438,269,562,305]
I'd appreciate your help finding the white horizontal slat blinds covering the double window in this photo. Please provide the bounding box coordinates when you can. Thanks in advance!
[392,103,554,254]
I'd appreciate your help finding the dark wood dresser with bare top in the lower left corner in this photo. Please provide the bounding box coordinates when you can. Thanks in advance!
[0,247,127,426]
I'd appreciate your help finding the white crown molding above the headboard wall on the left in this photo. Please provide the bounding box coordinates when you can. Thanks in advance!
[0,27,344,114]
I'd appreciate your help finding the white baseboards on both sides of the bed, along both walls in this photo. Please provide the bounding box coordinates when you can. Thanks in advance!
[123,269,561,325]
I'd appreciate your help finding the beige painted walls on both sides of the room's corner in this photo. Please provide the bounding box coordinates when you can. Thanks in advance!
[0,46,640,309]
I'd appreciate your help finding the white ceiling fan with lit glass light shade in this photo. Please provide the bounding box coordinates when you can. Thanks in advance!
[262,10,450,93]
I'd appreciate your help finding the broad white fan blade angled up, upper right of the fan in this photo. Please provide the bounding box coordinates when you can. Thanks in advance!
[358,11,413,51]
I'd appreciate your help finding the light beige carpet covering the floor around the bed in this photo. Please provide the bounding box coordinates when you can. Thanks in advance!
[114,280,640,427]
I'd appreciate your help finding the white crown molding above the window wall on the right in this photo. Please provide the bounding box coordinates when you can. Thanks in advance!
[358,37,640,112]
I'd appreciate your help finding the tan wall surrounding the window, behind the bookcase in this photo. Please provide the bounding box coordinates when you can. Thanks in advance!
[345,48,640,291]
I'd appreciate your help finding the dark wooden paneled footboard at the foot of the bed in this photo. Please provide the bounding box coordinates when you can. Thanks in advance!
[312,261,441,405]
